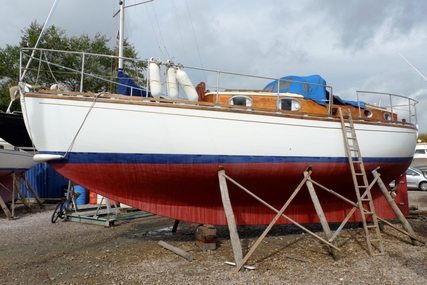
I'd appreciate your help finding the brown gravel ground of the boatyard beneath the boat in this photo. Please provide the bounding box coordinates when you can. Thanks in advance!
[0,191,427,284]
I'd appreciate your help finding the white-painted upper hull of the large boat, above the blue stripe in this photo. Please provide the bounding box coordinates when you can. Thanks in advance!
[23,97,416,158]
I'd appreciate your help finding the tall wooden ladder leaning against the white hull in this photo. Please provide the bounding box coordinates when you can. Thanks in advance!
[338,108,384,256]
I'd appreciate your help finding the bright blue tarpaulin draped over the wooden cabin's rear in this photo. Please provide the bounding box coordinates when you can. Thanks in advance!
[263,75,365,108]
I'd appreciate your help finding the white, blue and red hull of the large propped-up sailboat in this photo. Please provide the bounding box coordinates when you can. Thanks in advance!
[21,95,417,225]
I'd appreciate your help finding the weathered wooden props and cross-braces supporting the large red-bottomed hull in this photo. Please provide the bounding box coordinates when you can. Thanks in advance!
[218,167,422,273]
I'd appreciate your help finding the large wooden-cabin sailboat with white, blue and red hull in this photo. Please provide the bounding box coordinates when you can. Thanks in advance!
[16,1,418,225]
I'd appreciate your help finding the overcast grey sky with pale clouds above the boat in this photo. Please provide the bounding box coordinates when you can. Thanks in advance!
[0,0,427,133]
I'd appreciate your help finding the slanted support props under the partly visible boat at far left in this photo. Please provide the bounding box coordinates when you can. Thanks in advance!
[0,171,44,220]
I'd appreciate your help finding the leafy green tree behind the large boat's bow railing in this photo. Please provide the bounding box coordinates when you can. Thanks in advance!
[0,21,146,110]
